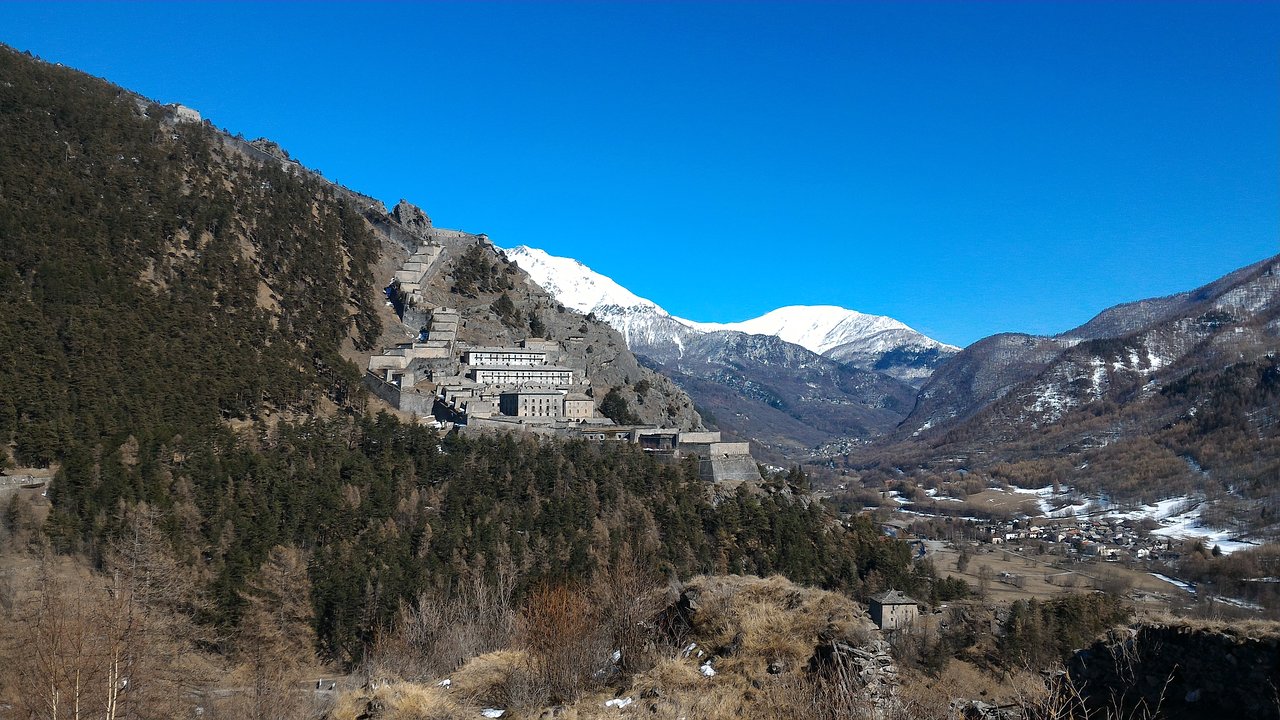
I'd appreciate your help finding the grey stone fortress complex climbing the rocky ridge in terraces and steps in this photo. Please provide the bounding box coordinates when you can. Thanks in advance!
[365,201,760,482]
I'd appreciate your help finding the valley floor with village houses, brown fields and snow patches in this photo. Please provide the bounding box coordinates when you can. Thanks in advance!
[837,474,1260,612]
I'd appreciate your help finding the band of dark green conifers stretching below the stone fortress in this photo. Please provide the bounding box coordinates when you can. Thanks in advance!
[45,415,927,661]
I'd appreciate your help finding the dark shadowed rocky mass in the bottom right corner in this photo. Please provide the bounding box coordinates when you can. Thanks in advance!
[1065,623,1280,720]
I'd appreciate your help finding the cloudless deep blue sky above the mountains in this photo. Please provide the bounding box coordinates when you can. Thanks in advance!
[0,3,1280,345]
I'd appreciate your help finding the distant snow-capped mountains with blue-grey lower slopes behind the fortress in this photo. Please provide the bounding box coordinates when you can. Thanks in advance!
[506,246,960,457]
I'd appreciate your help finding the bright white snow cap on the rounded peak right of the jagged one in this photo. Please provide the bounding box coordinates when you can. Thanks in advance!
[685,305,960,355]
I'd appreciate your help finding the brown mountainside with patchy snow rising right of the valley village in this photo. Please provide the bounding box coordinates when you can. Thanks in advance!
[847,252,1280,532]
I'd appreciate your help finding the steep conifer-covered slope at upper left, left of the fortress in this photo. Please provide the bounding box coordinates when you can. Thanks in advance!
[0,50,380,464]
